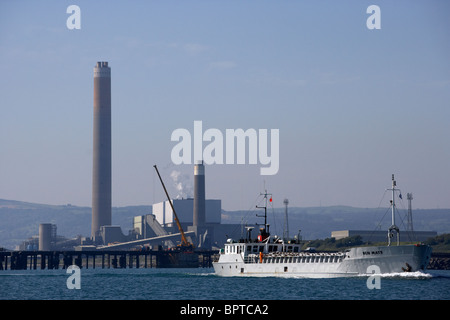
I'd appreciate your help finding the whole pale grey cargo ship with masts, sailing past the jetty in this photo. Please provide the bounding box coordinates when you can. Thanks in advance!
[213,177,431,278]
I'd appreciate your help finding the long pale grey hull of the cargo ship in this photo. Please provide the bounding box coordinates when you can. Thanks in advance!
[213,245,431,278]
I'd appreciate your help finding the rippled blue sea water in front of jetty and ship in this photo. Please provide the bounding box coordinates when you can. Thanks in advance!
[0,269,450,301]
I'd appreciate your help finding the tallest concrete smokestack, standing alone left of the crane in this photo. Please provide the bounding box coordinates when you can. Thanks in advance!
[91,62,111,238]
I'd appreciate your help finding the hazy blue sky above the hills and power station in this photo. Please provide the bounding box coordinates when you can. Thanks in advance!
[0,0,450,210]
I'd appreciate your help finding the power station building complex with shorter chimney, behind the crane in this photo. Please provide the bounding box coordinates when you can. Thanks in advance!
[75,162,241,250]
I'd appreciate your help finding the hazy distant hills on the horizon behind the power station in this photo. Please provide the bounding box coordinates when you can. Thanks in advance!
[0,199,450,249]
